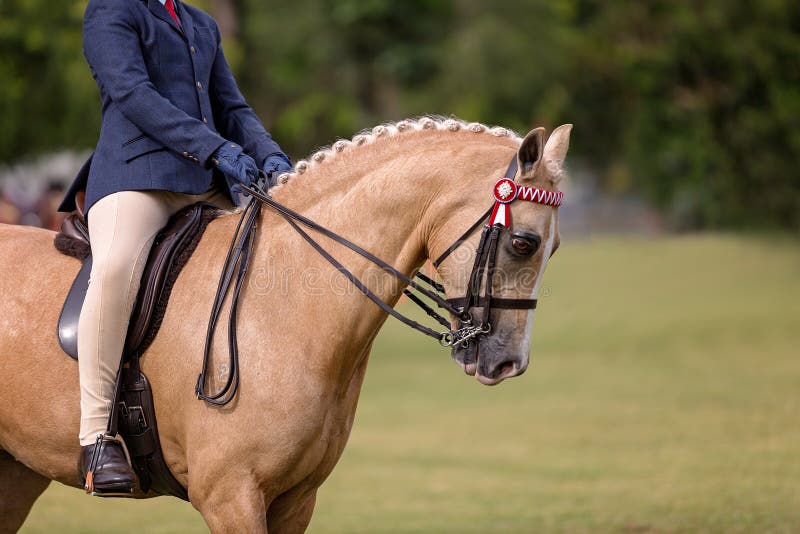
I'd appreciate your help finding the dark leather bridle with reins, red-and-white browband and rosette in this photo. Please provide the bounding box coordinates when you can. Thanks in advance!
[195,156,563,405]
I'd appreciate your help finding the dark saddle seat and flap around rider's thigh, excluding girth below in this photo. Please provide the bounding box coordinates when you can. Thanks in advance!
[55,202,221,359]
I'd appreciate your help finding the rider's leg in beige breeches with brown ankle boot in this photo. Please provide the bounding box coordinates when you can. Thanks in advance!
[78,191,180,494]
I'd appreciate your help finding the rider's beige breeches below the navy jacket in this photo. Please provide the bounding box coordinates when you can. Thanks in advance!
[78,189,232,445]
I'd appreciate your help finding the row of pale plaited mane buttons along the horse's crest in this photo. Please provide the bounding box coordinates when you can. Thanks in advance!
[278,116,521,184]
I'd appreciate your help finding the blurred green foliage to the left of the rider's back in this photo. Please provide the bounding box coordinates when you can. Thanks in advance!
[0,0,100,162]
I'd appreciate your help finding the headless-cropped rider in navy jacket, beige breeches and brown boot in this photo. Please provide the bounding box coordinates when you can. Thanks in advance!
[59,0,291,493]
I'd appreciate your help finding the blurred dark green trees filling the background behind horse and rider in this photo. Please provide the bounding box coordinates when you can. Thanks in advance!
[0,0,800,230]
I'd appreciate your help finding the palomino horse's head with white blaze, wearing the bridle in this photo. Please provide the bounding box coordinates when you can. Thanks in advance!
[432,124,572,385]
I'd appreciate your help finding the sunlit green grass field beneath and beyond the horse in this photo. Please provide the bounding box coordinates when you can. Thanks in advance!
[18,236,800,533]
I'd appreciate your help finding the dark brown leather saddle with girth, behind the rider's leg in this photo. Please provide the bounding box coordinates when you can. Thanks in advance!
[54,202,220,501]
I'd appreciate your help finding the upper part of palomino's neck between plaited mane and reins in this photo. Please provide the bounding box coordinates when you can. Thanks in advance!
[273,130,519,274]
